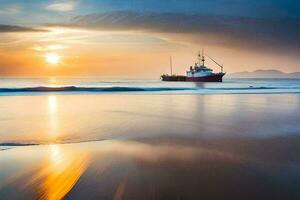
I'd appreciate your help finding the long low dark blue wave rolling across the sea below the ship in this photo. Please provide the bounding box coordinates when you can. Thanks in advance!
[0,86,300,93]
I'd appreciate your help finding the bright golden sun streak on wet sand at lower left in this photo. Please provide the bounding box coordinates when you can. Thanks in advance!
[26,145,89,200]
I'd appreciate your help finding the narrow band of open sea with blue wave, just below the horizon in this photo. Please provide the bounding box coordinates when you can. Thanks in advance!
[0,77,300,96]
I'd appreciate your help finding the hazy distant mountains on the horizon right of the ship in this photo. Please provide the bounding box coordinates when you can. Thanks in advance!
[228,69,300,78]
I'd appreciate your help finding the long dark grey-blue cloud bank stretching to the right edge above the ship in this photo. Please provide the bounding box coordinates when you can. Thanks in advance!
[52,11,300,51]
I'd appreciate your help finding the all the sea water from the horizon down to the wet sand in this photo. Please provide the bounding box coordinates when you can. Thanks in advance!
[0,78,300,144]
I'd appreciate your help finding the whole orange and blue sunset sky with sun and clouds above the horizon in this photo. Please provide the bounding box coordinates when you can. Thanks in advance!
[0,0,300,78]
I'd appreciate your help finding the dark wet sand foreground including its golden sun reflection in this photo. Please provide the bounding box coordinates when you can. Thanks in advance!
[0,138,300,200]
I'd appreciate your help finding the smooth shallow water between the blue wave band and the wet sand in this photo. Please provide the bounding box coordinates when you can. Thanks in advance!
[0,94,300,144]
